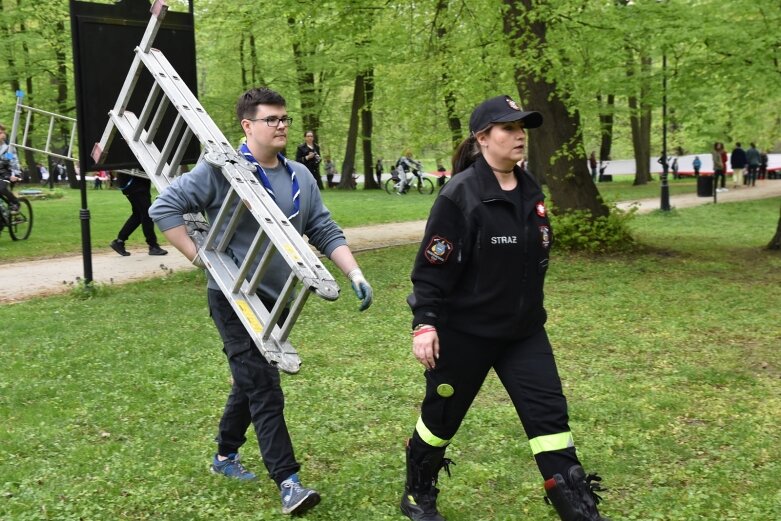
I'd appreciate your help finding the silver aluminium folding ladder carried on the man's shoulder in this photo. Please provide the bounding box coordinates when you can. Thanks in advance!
[92,0,339,373]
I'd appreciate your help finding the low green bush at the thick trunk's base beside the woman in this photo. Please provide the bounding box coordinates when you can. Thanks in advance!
[551,206,636,253]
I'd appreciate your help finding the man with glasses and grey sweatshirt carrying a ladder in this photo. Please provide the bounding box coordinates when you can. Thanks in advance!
[149,88,372,514]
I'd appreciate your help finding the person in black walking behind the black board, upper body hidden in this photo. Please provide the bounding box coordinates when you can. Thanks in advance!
[110,172,168,257]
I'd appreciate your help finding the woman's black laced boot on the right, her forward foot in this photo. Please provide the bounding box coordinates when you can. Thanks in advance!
[545,465,610,521]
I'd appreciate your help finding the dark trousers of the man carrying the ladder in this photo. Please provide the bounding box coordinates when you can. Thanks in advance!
[208,289,301,485]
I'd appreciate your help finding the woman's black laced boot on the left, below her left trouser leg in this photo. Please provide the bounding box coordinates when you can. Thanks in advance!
[401,445,455,521]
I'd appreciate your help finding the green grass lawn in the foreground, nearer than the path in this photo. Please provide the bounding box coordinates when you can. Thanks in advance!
[0,194,781,521]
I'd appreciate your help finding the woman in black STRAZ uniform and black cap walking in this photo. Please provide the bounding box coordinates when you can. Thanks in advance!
[401,96,606,521]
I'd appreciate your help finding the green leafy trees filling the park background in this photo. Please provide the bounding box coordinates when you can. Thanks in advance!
[0,0,781,215]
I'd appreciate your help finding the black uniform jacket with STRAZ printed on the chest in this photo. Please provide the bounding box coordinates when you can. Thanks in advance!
[408,156,553,338]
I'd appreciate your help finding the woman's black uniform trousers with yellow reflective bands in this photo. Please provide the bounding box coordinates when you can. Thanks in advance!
[411,328,579,479]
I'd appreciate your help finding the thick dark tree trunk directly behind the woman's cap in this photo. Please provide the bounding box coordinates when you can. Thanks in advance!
[504,0,609,217]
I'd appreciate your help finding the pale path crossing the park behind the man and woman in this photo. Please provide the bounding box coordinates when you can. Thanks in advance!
[0,180,781,304]
